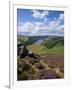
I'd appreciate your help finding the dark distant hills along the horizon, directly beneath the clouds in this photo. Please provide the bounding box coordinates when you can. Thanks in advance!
[17,35,64,47]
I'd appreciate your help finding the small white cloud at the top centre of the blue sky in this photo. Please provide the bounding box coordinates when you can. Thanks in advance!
[32,10,49,19]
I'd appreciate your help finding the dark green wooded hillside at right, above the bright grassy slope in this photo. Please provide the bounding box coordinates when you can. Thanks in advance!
[42,37,64,49]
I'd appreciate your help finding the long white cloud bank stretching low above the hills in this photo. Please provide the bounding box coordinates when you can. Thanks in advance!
[18,21,64,35]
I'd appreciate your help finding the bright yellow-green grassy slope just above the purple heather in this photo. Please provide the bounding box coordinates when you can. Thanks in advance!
[27,45,64,55]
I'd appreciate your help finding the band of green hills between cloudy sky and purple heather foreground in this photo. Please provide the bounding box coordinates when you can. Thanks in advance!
[17,36,64,55]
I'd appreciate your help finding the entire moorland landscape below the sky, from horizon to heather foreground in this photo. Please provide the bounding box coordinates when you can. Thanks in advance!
[17,36,64,81]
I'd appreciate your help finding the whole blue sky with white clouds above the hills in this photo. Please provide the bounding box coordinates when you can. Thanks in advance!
[17,8,64,36]
